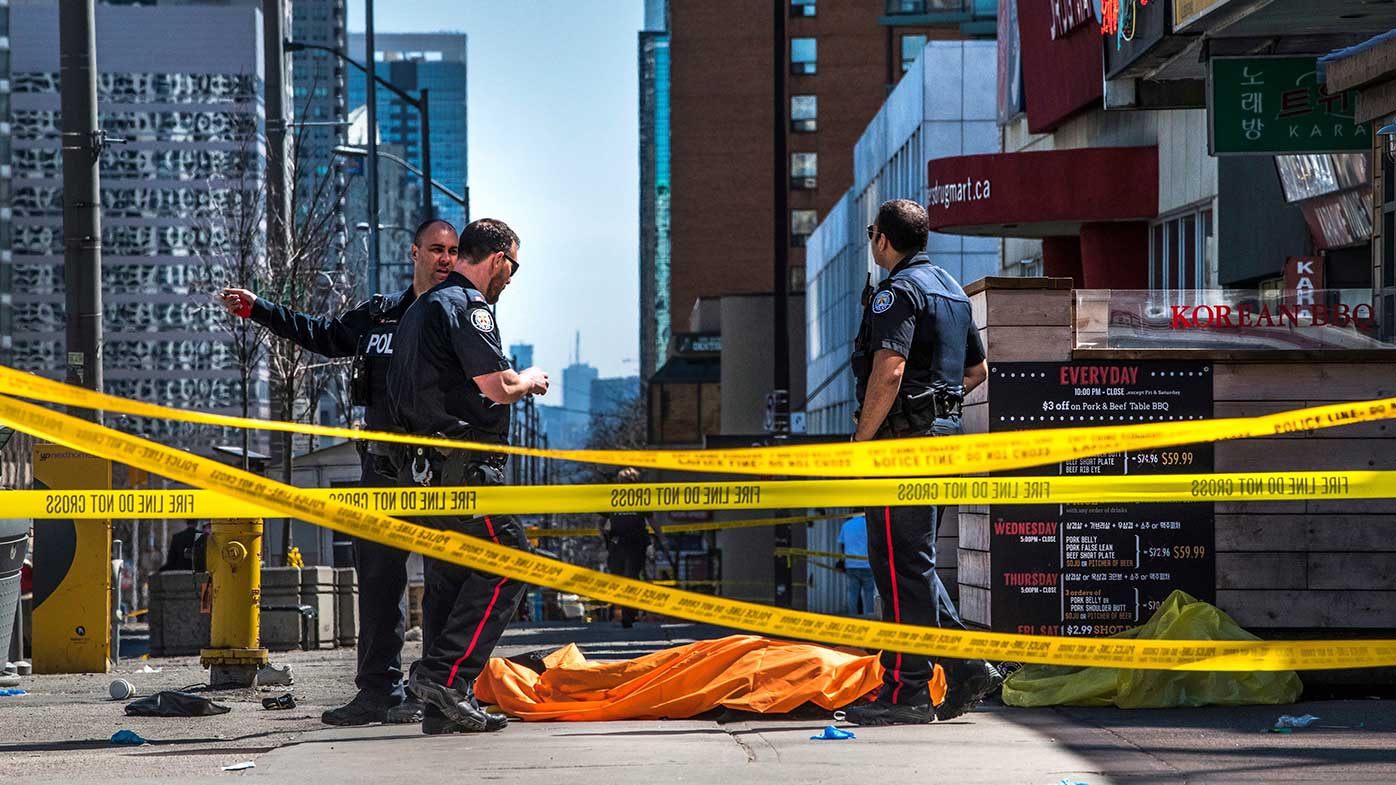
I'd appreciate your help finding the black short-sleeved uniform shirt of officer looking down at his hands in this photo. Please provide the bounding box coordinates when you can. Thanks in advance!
[388,272,510,443]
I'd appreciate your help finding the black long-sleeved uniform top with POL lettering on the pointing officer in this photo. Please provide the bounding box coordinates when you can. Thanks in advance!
[251,286,416,430]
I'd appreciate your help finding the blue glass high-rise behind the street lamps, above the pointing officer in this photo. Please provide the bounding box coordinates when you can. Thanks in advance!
[349,32,469,229]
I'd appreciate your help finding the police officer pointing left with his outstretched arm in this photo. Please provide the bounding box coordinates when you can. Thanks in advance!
[221,219,456,725]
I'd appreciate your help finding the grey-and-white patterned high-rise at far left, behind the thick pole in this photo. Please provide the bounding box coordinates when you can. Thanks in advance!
[9,1,267,447]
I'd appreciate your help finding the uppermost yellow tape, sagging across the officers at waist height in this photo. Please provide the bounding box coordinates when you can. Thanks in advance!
[0,366,1396,478]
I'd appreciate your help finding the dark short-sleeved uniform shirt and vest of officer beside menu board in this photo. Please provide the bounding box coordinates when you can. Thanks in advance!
[853,253,984,402]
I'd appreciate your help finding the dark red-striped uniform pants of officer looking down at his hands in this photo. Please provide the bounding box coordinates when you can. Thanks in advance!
[399,461,529,690]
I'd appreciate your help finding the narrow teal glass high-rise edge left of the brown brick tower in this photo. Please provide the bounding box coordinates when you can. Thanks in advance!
[639,0,673,380]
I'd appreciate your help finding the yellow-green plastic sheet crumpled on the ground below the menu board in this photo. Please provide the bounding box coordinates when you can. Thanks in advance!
[1004,591,1304,708]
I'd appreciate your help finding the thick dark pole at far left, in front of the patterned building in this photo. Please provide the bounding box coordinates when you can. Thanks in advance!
[59,0,103,422]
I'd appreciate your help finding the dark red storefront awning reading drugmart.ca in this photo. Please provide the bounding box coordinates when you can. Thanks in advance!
[927,147,1159,237]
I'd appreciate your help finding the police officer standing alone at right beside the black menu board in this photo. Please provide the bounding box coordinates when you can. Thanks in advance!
[847,200,1002,725]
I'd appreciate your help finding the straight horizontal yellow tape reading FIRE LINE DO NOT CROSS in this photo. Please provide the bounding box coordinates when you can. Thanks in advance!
[3,466,1396,516]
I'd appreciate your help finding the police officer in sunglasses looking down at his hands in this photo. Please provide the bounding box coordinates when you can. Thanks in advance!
[388,218,549,733]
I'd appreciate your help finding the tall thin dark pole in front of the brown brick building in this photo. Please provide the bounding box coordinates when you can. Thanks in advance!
[771,0,794,608]
